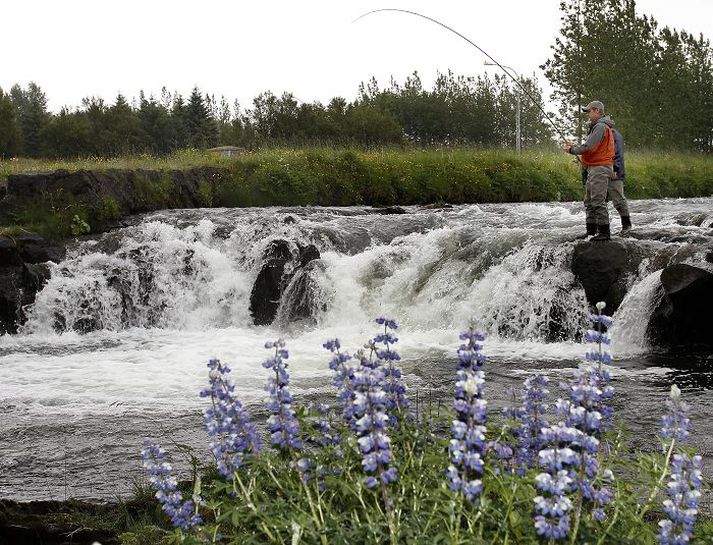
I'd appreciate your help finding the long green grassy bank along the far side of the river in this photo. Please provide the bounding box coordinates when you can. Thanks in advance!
[0,148,713,237]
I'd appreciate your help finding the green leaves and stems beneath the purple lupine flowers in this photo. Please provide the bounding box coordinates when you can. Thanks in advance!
[132,405,713,545]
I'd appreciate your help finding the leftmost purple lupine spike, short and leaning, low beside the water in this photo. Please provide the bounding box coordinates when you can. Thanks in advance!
[141,439,203,530]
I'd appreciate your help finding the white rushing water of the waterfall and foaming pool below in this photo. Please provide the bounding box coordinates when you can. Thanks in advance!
[0,199,713,497]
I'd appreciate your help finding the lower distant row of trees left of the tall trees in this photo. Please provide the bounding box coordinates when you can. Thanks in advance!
[0,72,551,158]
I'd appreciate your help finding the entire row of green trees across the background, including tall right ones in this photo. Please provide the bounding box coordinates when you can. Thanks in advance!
[0,0,713,158]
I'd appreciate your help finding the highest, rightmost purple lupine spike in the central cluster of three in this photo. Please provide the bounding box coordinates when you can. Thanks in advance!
[370,317,409,424]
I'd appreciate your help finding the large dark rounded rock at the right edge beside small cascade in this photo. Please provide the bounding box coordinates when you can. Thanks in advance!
[648,263,713,350]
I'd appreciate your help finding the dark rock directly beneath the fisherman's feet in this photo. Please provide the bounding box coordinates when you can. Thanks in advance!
[572,240,645,314]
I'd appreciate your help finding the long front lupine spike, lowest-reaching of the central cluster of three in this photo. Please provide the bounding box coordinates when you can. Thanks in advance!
[351,350,398,490]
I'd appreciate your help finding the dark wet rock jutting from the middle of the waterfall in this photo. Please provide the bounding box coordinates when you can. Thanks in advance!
[250,240,320,325]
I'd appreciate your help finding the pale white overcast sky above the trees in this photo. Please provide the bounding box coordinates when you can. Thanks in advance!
[0,0,713,111]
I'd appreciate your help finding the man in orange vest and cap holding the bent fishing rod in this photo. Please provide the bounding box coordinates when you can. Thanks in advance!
[563,100,616,240]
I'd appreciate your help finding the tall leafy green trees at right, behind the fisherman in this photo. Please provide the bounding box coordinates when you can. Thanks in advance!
[541,0,713,152]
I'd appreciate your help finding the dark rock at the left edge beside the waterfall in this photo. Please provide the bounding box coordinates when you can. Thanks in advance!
[0,233,58,334]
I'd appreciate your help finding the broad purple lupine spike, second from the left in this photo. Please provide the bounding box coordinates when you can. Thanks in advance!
[200,359,262,480]
